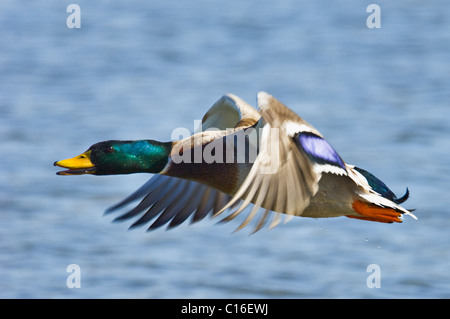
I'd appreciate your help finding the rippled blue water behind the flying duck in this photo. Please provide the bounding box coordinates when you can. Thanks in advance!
[0,0,450,298]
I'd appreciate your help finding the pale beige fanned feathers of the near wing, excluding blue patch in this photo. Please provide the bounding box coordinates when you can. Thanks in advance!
[216,93,321,229]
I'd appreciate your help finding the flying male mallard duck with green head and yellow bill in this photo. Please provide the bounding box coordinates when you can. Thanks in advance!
[54,92,416,231]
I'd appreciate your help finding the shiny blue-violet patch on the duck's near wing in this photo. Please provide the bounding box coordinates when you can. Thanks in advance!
[297,132,345,169]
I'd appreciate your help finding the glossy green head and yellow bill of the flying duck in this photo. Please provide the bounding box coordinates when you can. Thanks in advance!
[54,140,172,175]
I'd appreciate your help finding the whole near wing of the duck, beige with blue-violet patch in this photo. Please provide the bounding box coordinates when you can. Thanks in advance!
[217,92,347,229]
